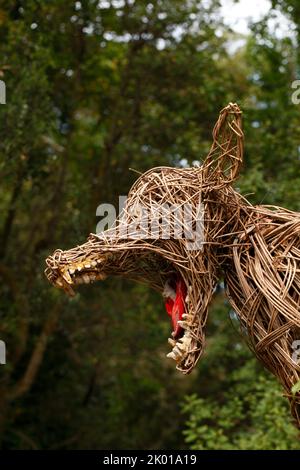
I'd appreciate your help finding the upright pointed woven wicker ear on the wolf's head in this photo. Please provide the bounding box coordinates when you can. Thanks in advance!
[204,103,244,186]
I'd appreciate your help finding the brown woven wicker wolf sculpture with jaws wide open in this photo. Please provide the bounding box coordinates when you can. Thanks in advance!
[45,103,300,427]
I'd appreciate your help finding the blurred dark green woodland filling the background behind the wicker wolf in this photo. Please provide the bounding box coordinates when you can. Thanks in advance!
[0,0,300,449]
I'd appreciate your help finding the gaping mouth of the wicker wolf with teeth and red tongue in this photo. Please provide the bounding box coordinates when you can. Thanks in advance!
[45,242,200,374]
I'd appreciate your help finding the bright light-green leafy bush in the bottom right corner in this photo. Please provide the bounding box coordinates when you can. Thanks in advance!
[183,365,300,450]
